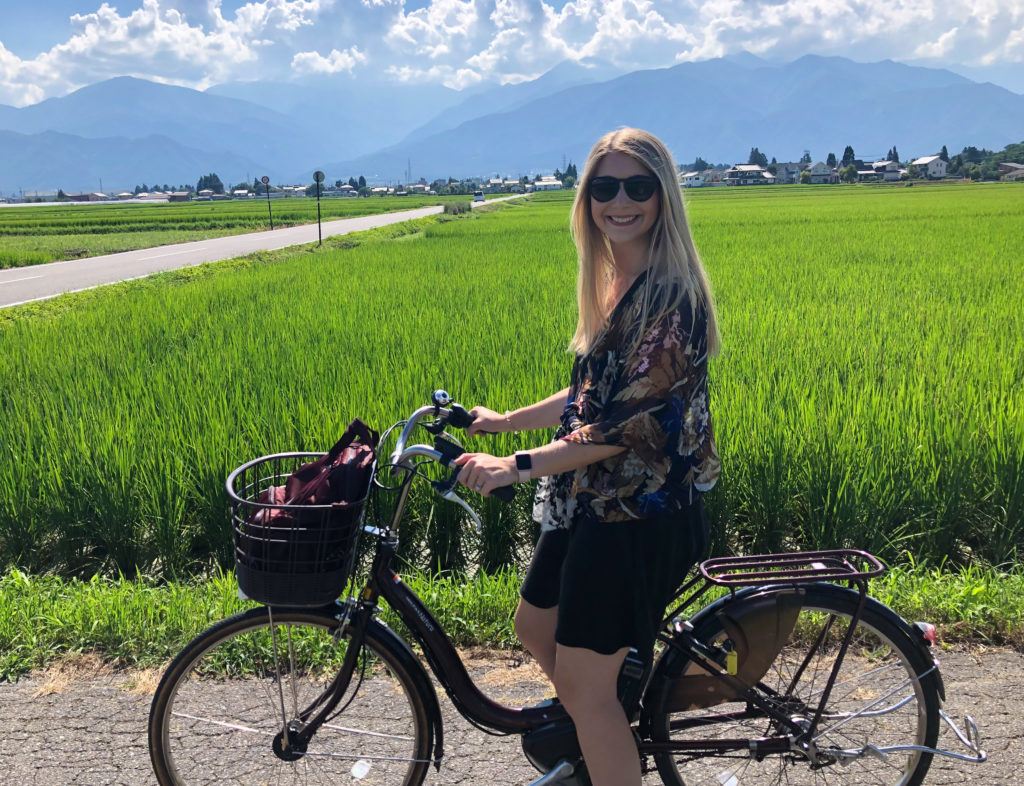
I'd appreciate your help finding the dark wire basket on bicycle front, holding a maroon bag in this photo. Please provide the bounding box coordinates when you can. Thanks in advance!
[227,452,376,607]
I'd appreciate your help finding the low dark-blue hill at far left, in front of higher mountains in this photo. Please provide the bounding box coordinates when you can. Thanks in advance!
[0,131,264,193]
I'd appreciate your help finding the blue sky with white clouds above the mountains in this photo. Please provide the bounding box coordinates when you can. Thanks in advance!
[0,0,1024,105]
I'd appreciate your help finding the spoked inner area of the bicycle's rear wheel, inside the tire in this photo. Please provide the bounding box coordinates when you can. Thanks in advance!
[654,596,937,786]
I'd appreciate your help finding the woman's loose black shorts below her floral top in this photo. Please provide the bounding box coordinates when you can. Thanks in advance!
[519,497,708,659]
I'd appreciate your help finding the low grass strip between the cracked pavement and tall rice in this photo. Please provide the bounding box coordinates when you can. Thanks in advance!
[0,564,1024,680]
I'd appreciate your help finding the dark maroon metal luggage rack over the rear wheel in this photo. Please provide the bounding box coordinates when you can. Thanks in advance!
[700,549,886,586]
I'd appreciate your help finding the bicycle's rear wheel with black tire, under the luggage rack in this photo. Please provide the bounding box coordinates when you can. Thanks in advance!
[645,583,941,786]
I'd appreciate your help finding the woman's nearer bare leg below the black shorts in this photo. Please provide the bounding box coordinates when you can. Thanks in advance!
[555,644,641,786]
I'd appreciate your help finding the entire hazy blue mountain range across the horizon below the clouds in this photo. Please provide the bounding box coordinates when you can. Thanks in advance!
[0,52,1024,192]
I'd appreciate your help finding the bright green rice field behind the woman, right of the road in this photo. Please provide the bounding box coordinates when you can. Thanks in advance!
[0,184,1024,576]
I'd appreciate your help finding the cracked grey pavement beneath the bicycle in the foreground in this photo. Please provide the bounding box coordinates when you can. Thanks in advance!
[0,649,1024,786]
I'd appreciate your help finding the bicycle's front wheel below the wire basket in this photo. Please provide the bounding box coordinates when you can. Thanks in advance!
[150,608,430,786]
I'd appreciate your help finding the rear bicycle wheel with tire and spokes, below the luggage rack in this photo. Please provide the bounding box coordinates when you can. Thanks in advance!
[648,584,939,786]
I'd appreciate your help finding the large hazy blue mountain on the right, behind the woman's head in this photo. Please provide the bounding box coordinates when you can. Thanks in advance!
[322,55,1024,179]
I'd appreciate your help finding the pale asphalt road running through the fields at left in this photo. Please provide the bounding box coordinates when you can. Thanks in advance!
[0,194,521,308]
